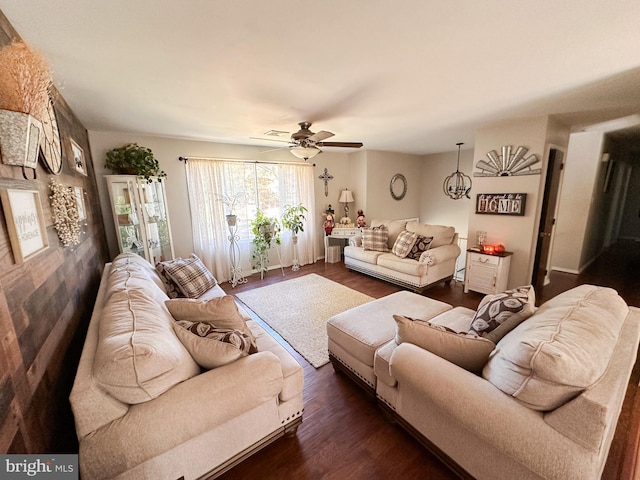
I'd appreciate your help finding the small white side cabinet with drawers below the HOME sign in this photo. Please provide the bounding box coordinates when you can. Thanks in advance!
[464,250,513,294]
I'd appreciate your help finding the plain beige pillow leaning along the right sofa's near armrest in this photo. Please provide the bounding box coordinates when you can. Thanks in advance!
[393,315,495,372]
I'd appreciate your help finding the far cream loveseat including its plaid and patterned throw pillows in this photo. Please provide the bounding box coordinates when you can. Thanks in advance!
[344,220,460,292]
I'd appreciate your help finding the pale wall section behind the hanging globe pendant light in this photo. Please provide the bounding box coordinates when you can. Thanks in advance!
[419,149,475,238]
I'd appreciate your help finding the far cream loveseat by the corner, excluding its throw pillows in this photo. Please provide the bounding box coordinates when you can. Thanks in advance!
[344,220,460,292]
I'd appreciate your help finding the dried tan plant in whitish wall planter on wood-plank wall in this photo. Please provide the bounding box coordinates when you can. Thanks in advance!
[0,41,53,168]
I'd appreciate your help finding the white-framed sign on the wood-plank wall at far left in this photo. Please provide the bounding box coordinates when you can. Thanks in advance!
[0,188,49,264]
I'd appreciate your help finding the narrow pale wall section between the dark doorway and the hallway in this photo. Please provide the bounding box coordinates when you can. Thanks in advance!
[551,132,604,273]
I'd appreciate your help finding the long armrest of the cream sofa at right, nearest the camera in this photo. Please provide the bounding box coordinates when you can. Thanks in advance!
[389,343,588,478]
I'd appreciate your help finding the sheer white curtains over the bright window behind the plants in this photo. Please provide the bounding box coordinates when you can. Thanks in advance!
[186,159,318,281]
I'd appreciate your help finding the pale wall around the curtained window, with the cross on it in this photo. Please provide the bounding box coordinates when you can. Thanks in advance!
[89,131,349,258]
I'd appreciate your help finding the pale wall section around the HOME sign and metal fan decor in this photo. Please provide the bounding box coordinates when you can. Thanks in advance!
[468,117,548,288]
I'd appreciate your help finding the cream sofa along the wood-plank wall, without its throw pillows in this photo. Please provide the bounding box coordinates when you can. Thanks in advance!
[70,254,303,480]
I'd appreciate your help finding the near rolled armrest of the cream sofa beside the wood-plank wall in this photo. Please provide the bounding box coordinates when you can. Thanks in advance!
[81,352,282,477]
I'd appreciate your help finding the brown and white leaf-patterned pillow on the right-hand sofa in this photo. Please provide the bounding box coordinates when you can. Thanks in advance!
[469,285,536,343]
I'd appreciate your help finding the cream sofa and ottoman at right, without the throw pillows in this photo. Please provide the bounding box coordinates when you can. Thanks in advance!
[327,285,640,480]
